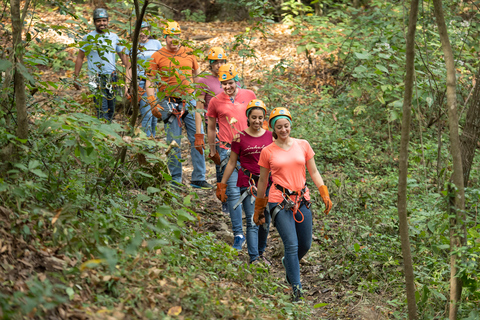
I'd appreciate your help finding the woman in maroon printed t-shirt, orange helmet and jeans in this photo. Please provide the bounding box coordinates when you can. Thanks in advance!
[217,99,273,265]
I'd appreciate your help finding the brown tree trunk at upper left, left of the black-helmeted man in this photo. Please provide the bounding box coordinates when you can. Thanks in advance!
[10,0,28,139]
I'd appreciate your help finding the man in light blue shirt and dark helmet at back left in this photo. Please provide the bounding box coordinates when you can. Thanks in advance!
[74,8,129,122]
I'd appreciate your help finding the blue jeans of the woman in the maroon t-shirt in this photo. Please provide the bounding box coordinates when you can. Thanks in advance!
[240,188,270,262]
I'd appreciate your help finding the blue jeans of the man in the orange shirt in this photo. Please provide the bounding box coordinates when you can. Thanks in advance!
[162,100,207,183]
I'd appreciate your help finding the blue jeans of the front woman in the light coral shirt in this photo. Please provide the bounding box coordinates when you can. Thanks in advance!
[268,203,312,290]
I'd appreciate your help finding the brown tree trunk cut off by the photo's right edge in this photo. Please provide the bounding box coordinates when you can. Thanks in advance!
[460,69,480,187]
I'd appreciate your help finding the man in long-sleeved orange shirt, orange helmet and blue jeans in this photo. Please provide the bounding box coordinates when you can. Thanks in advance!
[145,22,213,189]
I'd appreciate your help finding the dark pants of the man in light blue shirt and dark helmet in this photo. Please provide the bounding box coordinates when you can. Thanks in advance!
[93,74,117,122]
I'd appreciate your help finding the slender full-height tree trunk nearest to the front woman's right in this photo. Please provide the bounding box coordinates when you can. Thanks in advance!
[398,0,418,320]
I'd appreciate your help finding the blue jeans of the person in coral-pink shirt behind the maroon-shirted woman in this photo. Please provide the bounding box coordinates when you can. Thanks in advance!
[217,145,243,236]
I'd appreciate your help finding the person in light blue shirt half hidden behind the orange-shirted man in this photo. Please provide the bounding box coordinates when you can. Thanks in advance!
[125,21,162,137]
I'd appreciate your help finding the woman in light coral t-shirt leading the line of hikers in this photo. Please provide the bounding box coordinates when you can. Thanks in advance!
[253,108,332,302]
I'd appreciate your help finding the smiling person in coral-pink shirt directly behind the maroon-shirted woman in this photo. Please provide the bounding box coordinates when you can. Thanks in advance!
[207,63,256,250]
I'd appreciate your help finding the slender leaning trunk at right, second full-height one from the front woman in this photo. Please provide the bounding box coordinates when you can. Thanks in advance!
[433,0,465,320]
